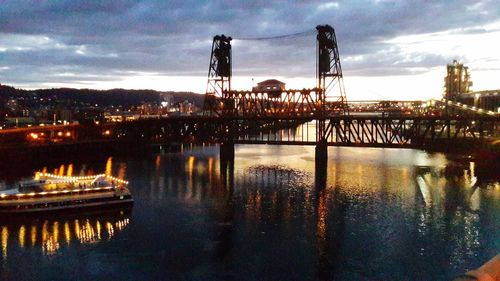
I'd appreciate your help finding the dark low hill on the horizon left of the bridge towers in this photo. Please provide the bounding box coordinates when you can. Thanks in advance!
[0,85,204,107]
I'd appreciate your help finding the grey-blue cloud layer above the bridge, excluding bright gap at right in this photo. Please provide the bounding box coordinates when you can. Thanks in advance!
[0,0,500,89]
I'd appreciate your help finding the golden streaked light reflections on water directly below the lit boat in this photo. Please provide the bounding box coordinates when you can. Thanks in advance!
[0,210,130,261]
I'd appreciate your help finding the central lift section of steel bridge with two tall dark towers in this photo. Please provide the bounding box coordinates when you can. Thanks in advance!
[204,25,349,168]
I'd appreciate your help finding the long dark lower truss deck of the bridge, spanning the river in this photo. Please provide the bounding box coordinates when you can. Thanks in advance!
[0,116,500,150]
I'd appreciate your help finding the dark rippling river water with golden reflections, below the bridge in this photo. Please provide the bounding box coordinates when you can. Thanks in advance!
[0,145,500,280]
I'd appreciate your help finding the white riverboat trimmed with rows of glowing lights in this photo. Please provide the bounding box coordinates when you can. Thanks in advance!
[0,173,133,214]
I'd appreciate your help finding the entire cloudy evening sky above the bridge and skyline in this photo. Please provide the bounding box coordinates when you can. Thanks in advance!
[0,0,500,100]
